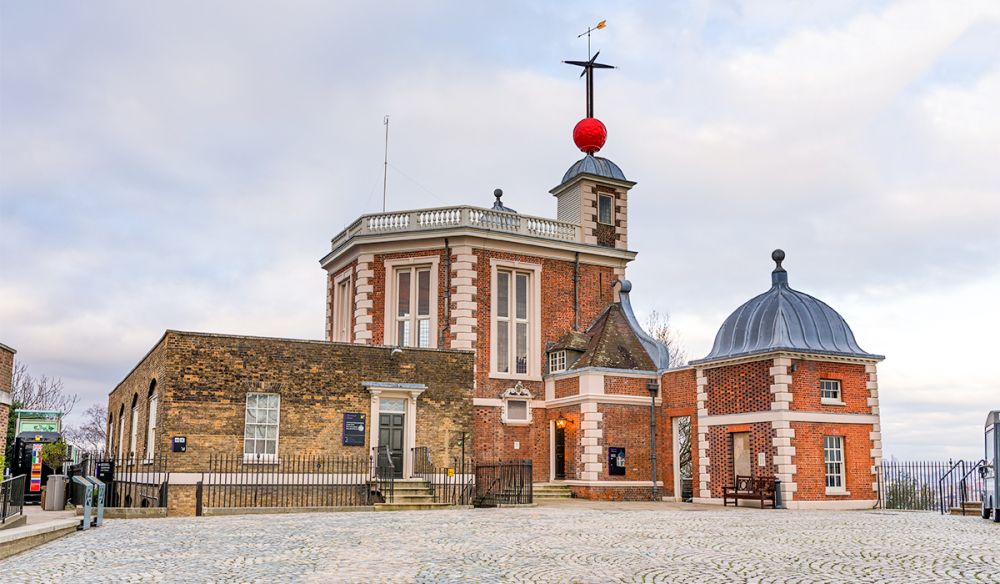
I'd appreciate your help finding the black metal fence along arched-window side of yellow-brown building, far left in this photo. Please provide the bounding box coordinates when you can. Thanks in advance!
[68,452,170,507]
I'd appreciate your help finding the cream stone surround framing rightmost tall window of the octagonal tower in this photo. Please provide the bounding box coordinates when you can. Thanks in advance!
[490,259,542,381]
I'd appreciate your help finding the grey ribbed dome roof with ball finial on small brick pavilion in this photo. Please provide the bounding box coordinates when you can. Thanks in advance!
[691,249,884,364]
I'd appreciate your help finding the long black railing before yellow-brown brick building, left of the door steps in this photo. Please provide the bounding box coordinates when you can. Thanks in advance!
[201,454,382,509]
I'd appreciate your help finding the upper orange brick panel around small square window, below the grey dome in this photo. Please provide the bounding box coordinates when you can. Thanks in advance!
[791,360,871,414]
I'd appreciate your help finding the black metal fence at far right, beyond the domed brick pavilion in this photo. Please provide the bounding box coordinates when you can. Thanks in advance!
[878,460,985,513]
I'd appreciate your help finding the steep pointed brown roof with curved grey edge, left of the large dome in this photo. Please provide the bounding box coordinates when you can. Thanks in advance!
[551,280,669,371]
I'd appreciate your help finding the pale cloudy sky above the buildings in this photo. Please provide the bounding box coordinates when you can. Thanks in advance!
[0,0,1000,459]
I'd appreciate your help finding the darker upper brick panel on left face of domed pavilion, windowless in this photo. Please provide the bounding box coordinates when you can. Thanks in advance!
[705,359,773,416]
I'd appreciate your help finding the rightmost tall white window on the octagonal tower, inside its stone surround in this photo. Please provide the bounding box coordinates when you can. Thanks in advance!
[494,270,531,375]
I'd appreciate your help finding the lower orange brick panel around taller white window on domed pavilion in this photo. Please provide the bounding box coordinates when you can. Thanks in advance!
[791,422,876,501]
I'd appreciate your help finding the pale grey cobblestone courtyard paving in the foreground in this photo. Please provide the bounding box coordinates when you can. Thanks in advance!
[0,504,1000,584]
